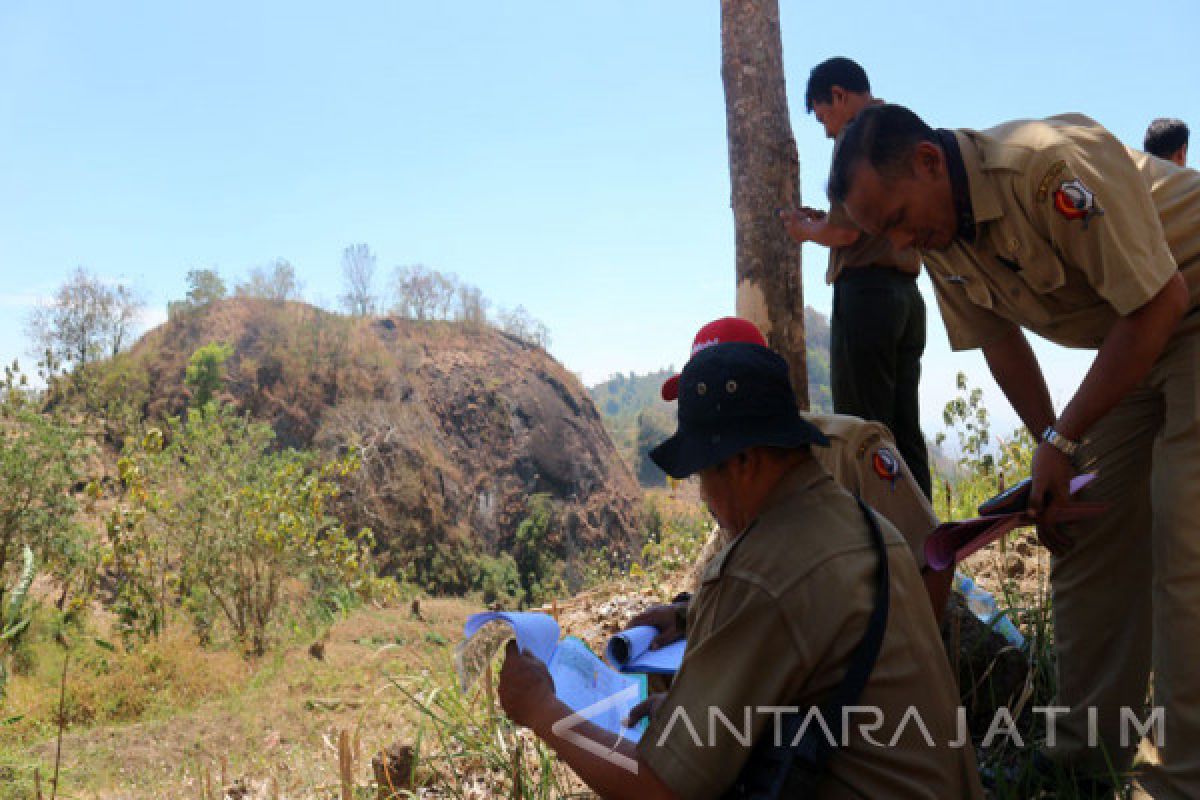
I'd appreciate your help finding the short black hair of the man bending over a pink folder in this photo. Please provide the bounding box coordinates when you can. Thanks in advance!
[829,104,937,203]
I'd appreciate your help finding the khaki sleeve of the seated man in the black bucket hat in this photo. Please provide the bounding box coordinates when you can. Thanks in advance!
[637,576,812,800]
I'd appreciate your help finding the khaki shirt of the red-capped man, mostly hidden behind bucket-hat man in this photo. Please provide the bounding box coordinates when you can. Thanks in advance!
[688,414,937,594]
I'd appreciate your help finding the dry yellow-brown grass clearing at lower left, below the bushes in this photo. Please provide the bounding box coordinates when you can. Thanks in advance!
[0,600,487,800]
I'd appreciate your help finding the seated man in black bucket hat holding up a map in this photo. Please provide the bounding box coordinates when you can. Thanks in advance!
[499,342,982,799]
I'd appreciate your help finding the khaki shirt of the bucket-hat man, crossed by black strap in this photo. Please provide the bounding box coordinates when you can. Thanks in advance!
[637,462,983,800]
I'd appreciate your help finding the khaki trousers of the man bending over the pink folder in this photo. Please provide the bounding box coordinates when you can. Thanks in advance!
[1048,312,1200,798]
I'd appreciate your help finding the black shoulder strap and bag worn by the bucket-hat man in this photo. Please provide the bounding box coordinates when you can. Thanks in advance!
[724,497,890,800]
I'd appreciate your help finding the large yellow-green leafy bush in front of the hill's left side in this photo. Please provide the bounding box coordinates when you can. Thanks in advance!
[108,403,376,655]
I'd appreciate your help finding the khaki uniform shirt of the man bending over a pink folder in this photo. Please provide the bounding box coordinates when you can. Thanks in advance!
[922,114,1200,350]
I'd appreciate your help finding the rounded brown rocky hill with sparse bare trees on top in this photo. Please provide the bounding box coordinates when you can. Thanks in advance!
[131,299,640,591]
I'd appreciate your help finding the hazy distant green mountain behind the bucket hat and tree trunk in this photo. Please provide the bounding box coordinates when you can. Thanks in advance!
[588,307,833,487]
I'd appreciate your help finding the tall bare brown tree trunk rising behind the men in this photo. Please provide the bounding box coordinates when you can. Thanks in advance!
[721,0,809,410]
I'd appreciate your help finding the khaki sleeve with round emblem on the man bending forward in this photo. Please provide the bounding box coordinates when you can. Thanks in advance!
[1021,130,1178,317]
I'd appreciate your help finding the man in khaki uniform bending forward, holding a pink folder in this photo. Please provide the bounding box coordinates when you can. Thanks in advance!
[829,106,1200,798]
